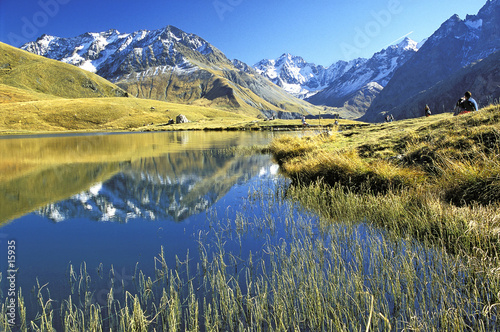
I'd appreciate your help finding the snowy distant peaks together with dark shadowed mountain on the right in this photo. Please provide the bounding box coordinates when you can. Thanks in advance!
[253,0,500,122]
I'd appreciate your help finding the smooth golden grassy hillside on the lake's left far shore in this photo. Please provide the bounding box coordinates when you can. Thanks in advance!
[0,43,254,133]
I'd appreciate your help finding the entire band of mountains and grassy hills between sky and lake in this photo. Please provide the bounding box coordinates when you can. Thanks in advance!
[0,0,500,133]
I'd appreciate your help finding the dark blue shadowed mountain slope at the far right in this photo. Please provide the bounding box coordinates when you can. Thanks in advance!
[361,0,500,122]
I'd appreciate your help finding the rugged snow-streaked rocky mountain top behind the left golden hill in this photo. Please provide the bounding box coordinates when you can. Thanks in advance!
[22,26,225,81]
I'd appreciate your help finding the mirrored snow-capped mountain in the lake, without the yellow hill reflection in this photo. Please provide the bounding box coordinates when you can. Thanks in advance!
[38,151,277,222]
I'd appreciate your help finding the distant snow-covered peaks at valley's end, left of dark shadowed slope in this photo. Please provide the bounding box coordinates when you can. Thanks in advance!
[253,38,421,115]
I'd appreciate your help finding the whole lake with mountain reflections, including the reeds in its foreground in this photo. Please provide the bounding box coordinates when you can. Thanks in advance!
[0,132,498,331]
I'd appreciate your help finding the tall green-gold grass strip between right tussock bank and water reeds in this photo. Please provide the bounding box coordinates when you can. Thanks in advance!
[288,181,500,260]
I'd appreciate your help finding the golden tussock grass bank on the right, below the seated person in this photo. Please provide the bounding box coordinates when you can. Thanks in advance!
[271,106,500,192]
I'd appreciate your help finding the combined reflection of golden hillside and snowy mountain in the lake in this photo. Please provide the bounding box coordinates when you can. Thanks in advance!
[0,132,282,223]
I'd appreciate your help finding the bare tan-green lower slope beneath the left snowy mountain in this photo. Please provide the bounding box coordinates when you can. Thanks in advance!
[117,64,323,117]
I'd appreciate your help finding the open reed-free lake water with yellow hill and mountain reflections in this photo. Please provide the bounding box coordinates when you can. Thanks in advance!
[0,132,294,304]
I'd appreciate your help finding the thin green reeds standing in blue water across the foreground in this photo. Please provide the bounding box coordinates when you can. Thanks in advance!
[0,182,500,331]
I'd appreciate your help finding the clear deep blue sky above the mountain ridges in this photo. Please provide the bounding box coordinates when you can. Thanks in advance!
[0,0,486,66]
